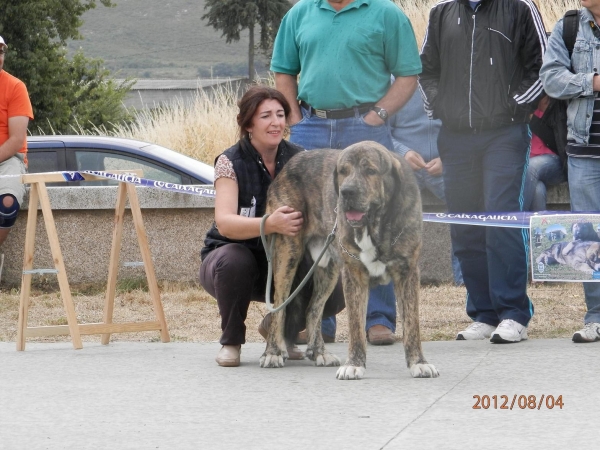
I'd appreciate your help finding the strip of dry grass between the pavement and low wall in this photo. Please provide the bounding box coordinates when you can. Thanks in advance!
[0,283,585,342]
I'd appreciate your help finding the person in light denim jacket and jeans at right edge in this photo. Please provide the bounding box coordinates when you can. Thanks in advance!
[540,0,600,342]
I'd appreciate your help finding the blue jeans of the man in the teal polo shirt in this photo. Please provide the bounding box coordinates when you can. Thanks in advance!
[290,104,396,330]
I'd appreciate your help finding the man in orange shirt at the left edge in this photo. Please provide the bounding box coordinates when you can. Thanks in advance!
[0,36,33,245]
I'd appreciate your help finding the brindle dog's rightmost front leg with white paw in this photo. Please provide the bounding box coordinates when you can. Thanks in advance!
[394,268,439,378]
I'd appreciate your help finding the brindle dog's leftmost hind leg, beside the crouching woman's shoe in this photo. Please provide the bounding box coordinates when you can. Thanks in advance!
[260,234,303,367]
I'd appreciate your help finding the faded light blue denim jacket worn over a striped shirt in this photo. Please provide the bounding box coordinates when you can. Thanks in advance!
[540,8,600,144]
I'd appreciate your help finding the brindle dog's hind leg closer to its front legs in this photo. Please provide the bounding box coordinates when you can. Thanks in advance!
[306,263,341,367]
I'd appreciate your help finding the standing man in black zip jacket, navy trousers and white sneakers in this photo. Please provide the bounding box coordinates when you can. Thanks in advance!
[419,0,546,343]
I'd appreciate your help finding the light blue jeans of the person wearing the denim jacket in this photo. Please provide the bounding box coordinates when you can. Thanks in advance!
[569,157,600,323]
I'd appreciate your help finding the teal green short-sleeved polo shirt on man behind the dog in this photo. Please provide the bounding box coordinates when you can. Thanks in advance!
[271,0,421,109]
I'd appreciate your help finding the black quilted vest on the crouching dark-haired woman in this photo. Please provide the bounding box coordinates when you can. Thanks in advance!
[200,138,304,260]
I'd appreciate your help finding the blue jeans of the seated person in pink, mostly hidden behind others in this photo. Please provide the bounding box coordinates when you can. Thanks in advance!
[524,154,567,211]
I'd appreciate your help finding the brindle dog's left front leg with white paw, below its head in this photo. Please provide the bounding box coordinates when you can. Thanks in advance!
[336,265,369,380]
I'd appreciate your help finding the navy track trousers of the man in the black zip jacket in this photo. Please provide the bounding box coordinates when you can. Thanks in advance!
[438,124,533,326]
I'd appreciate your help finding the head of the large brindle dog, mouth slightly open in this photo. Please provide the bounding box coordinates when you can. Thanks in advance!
[334,141,402,227]
